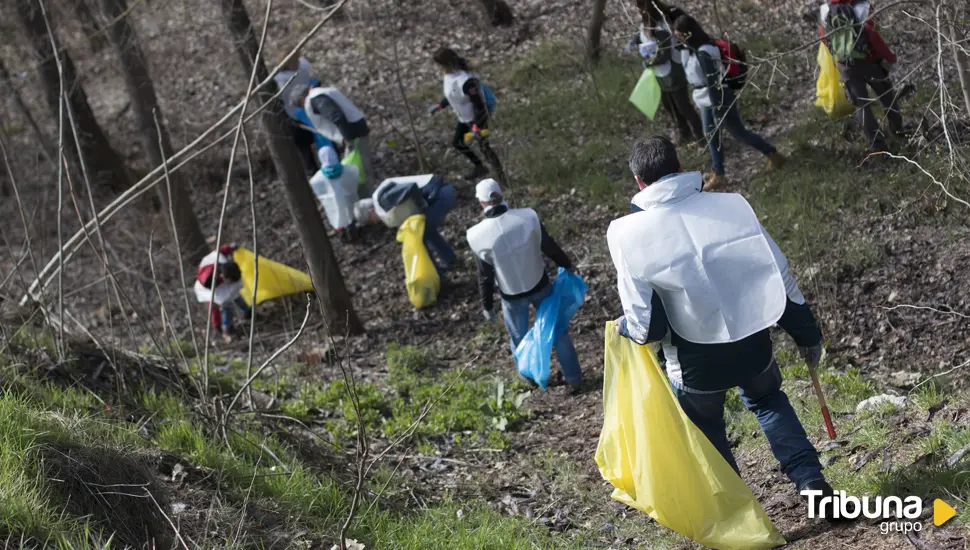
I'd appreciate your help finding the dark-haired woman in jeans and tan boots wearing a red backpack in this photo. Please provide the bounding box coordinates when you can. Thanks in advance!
[674,15,786,191]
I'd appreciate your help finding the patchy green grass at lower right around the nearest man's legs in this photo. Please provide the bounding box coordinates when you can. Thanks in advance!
[726,350,970,526]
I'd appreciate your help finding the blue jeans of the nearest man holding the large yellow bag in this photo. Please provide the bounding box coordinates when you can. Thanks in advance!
[671,361,824,490]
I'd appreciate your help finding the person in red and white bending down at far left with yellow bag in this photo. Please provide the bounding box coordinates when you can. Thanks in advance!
[195,244,252,344]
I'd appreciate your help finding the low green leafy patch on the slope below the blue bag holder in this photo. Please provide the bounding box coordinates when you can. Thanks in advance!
[281,345,529,449]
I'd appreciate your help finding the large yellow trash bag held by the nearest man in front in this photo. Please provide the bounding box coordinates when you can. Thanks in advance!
[596,321,785,550]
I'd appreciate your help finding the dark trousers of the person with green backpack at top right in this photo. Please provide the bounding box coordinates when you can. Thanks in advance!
[839,63,903,151]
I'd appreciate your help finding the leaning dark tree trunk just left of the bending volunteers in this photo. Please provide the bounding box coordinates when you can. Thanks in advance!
[219,0,364,335]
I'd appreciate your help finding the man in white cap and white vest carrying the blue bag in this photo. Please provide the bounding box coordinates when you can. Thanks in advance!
[466,183,583,394]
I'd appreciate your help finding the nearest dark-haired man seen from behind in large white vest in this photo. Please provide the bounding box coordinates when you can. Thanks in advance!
[606,137,832,517]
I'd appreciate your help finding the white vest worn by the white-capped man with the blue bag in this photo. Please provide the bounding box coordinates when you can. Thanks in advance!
[465,208,545,295]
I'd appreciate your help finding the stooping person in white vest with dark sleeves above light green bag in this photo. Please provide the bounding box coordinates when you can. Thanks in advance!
[300,86,375,195]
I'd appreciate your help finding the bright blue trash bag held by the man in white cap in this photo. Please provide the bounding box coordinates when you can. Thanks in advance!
[515,267,586,390]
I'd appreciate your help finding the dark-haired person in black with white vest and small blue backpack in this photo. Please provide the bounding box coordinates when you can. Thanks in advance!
[428,48,505,182]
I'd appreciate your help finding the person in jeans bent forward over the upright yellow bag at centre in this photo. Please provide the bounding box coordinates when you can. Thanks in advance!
[354,174,460,279]
